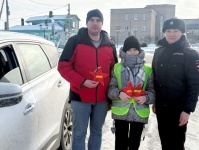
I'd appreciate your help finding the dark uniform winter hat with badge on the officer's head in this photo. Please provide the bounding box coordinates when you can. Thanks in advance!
[162,18,185,33]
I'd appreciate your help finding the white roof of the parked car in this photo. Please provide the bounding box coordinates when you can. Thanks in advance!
[0,31,55,46]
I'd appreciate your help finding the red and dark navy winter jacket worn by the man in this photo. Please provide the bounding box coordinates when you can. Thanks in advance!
[58,28,117,103]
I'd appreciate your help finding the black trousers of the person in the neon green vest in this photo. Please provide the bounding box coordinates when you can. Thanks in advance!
[115,120,144,150]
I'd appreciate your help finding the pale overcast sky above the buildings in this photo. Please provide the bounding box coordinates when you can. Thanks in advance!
[0,0,199,32]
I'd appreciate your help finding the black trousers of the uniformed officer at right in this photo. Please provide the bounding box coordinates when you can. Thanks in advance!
[157,111,187,150]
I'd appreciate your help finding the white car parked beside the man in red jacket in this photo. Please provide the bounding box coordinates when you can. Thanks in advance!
[0,31,72,150]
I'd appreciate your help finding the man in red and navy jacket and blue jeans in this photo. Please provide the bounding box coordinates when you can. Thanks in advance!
[58,9,117,150]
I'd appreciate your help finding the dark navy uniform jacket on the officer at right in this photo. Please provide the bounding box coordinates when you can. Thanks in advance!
[152,35,199,113]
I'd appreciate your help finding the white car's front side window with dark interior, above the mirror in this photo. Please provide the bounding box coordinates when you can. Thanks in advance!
[0,45,23,85]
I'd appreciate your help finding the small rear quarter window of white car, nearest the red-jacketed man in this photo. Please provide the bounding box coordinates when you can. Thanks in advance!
[45,45,59,67]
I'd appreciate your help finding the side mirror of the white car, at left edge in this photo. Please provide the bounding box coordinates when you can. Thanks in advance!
[0,82,22,108]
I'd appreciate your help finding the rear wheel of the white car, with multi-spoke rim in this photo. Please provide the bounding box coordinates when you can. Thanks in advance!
[60,105,73,150]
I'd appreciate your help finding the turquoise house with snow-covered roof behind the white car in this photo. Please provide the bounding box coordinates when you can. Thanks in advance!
[9,11,80,45]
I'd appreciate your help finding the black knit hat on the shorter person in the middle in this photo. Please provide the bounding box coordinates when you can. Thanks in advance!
[123,36,141,53]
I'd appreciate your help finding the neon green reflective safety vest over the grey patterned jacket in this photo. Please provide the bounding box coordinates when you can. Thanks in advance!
[111,63,152,118]
